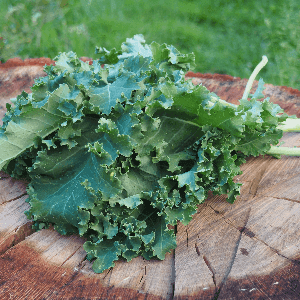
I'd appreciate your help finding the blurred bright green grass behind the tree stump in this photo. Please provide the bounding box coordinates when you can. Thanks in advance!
[0,0,300,89]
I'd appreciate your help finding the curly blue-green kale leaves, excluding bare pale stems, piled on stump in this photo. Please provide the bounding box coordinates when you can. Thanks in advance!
[0,35,296,273]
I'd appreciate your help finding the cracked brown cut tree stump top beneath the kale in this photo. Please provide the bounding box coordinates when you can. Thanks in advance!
[0,58,300,300]
